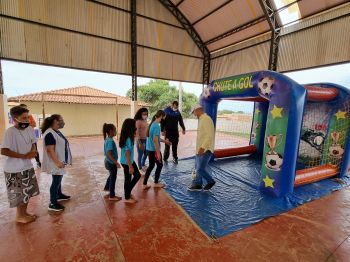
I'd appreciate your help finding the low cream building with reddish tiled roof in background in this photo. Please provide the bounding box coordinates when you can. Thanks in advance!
[8,86,149,136]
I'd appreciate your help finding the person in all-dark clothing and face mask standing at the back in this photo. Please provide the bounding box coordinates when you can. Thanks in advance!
[161,101,186,164]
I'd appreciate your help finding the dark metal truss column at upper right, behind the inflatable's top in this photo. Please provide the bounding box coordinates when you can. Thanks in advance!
[259,0,281,71]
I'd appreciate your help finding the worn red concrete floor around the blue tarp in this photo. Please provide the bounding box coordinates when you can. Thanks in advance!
[0,134,350,262]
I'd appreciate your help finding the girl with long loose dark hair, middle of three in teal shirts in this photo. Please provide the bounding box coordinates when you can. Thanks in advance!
[119,118,141,203]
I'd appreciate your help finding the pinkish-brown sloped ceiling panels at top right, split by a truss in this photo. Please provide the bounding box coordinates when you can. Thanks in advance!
[171,0,349,52]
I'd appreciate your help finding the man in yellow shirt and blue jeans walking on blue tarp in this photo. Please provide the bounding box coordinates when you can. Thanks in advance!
[188,105,215,191]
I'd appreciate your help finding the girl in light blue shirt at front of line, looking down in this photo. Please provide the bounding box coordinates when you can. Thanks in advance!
[143,110,171,190]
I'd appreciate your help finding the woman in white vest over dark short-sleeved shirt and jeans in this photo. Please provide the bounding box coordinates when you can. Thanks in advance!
[41,114,72,212]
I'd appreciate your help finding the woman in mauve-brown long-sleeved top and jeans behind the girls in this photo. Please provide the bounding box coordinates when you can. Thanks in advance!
[134,107,148,173]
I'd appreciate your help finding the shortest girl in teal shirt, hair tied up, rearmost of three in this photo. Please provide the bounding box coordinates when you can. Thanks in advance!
[102,123,122,201]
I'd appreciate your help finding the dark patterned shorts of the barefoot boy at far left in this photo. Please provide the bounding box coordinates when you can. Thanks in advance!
[5,168,40,207]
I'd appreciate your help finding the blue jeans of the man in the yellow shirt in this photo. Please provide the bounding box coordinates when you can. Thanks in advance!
[193,151,214,186]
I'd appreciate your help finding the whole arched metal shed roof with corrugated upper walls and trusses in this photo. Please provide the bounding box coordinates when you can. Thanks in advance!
[0,0,350,100]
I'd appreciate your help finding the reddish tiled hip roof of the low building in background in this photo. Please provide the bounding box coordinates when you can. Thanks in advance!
[8,86,149,106]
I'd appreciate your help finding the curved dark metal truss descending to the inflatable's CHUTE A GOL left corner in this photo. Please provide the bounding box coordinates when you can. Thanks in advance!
[159,0,210,85]
